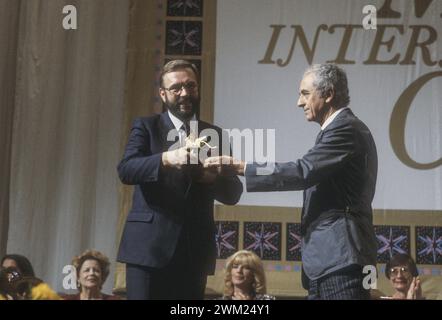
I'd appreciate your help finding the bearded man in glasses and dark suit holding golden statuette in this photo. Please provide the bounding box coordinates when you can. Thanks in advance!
[117,60,242,299]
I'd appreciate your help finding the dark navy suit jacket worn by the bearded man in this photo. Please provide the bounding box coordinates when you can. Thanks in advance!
[117,112,242,274]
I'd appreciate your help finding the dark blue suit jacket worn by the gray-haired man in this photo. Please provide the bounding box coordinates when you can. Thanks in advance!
[245,109,377,279]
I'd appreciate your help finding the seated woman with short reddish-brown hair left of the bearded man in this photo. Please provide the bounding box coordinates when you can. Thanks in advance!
[62,250,120,300]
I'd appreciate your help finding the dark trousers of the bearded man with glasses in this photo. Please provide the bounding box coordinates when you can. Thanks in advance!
[126,228,207,300]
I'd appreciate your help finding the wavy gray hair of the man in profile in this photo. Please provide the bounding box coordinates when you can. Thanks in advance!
[304,63,350,108]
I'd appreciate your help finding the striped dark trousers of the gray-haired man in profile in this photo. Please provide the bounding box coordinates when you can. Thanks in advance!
[308,265,370,300]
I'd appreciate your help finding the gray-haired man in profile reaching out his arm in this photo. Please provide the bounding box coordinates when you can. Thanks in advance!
[205,64,377,299]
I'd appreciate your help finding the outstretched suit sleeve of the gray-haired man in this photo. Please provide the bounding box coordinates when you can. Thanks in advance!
[245,125,358,192]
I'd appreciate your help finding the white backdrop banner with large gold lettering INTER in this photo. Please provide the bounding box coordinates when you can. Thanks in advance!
[214,0,442,210]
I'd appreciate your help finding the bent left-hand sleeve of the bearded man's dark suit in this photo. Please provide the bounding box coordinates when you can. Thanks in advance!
[117,119,161,185]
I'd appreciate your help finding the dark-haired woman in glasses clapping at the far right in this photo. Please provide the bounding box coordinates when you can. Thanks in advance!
[382,254,424,300]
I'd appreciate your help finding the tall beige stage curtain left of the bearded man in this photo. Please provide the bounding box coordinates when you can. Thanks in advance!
[6,0,129,292]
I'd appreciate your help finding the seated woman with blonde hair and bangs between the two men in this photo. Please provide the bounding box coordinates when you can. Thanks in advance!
[221,250,275,300]
